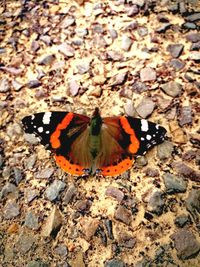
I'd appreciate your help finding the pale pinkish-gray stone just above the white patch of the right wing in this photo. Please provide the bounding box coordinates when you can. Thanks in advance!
[136,97,155,119]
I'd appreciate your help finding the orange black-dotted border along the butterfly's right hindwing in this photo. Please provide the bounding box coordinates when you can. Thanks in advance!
[101,158,133,176]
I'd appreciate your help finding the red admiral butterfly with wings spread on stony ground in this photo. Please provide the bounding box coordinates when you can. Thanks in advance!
[22,108,166,176]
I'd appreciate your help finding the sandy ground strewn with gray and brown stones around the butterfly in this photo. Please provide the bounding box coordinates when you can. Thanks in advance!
[0,0,200,267]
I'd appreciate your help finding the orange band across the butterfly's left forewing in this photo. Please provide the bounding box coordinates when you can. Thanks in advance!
[50,112,74,148]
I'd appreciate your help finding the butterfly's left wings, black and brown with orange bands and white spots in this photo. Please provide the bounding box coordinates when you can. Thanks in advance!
[22,112,91,175]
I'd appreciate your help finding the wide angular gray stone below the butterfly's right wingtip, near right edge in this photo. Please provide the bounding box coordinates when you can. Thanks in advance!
[163,173,187,194]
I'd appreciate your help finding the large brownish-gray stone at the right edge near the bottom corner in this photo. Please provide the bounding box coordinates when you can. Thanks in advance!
[170,229,200,260]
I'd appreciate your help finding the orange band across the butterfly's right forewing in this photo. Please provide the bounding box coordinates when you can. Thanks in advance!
[120,117,140,154]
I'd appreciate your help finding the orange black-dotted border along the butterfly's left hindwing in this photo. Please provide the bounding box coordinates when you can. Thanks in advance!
[54,155,84,176]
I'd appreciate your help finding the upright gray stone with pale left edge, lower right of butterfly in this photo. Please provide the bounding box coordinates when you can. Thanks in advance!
[147,190,165,215]
